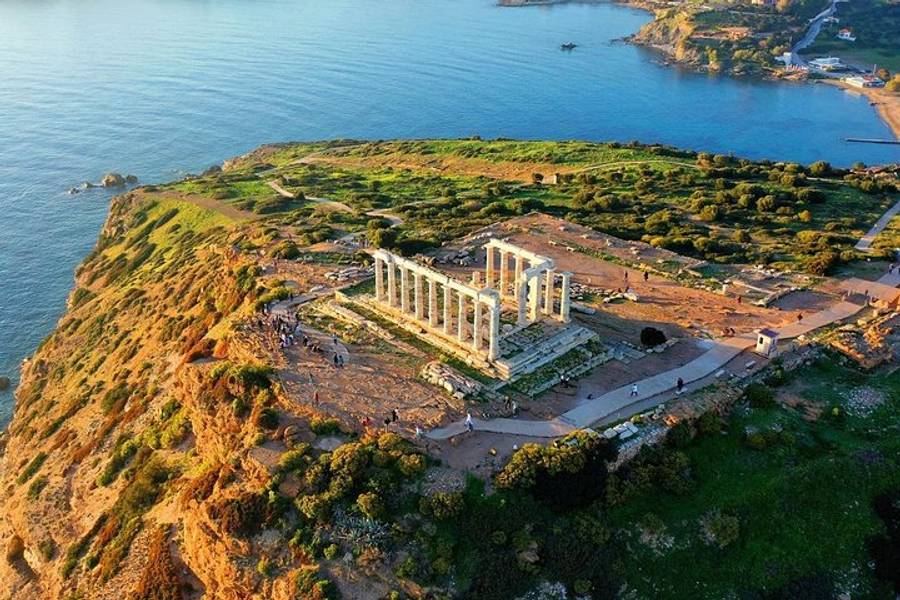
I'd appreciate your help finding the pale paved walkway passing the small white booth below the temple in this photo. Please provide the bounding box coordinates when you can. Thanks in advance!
[427,302,863,440]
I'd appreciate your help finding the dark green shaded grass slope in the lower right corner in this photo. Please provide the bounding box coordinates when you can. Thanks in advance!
[610,361,900,598]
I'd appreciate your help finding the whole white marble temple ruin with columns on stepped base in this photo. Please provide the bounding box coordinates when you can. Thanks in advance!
[369,239,593,379]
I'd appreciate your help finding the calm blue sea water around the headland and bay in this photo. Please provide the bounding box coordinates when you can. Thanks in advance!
[0,0,900,426]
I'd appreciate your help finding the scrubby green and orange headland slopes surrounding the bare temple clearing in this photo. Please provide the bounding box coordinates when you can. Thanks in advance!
[0,139,900,600]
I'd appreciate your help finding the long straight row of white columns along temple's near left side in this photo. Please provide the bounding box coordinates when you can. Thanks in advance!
[374,251,501,360]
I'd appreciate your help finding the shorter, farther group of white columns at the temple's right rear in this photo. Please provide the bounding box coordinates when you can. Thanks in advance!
[485,240,572,325]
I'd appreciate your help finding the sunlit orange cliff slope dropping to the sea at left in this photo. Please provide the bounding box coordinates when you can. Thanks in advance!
[0,190,284,599]
